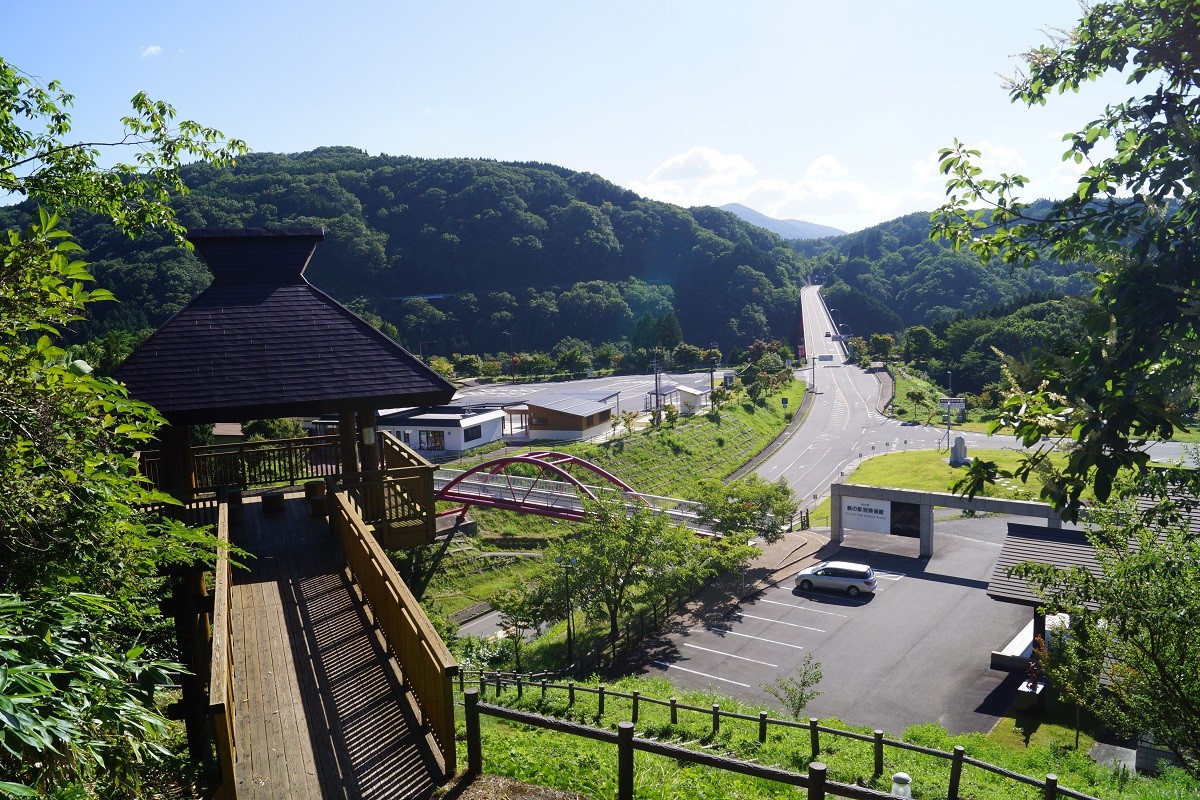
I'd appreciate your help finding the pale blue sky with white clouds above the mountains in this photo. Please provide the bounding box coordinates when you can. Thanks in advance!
[7,0,1132,230]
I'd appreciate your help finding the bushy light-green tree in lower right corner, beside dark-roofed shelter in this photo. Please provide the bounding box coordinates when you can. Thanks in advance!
[1010,469,1200,777]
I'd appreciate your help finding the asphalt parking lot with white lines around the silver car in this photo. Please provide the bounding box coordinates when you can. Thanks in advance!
[643,517,1031,733]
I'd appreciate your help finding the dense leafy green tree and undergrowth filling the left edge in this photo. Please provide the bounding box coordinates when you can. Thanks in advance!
[0,59,245,796]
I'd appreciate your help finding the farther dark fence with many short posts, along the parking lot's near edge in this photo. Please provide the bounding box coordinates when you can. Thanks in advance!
[458,670,1097,800]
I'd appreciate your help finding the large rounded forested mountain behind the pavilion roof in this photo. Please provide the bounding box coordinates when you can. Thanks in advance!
[0,148,805,362]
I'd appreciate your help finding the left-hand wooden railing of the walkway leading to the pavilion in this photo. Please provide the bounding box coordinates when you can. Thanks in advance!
[209,501,238,800]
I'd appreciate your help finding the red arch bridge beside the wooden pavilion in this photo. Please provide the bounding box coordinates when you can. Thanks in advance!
[433,450,707,531]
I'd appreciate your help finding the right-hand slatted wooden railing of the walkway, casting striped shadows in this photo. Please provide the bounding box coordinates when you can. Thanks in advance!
[329,492,458,775]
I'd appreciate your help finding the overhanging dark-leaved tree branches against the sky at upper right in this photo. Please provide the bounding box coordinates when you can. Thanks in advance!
[931,0,1200,518]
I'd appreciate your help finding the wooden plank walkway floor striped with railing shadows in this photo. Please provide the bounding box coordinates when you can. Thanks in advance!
[233,495,440,800]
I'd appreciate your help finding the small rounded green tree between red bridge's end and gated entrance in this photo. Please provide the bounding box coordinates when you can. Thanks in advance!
[697,474,798,543]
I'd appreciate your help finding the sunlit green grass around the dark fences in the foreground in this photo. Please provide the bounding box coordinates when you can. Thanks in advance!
[460,676,1200,800]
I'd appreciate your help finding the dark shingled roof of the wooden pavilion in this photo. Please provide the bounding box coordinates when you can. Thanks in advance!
[115,228,454,425]
